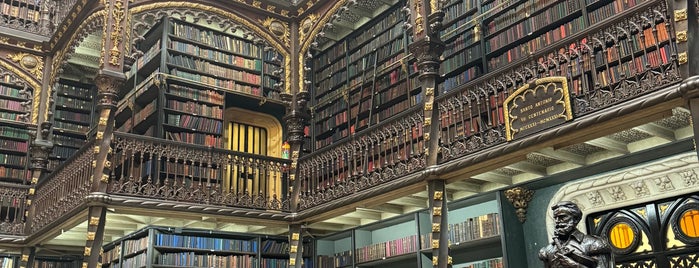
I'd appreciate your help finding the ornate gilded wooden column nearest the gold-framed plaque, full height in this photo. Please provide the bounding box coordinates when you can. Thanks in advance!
[408,0,451,267]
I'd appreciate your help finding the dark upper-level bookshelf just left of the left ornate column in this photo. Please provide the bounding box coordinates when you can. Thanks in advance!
[49,79,95,169]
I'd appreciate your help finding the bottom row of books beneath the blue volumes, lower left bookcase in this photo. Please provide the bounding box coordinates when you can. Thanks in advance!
[156,252,260,268]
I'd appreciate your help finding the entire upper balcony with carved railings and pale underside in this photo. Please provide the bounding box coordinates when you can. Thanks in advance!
[2,1,693,249]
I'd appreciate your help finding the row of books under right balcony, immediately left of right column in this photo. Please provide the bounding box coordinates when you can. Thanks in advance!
[355,235,418,263]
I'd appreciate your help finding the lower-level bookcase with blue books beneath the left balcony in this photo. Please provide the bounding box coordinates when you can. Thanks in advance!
[102,227,304,268]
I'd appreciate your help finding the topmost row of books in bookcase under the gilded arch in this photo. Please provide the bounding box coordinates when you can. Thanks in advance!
[170,20,262,58]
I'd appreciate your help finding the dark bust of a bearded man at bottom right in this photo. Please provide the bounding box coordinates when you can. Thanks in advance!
[539,201,613,268]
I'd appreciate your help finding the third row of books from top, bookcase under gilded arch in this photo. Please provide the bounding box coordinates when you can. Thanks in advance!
[167,54,260,84]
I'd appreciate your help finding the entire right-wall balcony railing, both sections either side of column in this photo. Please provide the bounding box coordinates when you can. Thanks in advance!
[299,1,682,209]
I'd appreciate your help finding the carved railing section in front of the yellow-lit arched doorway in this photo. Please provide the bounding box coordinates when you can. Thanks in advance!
[108,133,291,211]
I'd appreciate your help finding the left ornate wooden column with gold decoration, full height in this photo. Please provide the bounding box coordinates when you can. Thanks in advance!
[82,0,130,268]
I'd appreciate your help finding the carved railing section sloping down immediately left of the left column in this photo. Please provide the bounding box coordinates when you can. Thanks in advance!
[30,138,95,233]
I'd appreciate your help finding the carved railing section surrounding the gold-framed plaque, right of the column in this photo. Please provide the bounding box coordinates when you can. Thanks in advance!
[437,1,682,163]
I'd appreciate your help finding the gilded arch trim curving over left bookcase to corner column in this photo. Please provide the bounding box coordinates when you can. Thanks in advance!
[129,0,290,92]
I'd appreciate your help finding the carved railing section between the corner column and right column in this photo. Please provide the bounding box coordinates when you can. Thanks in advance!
[299,107,426,209]
